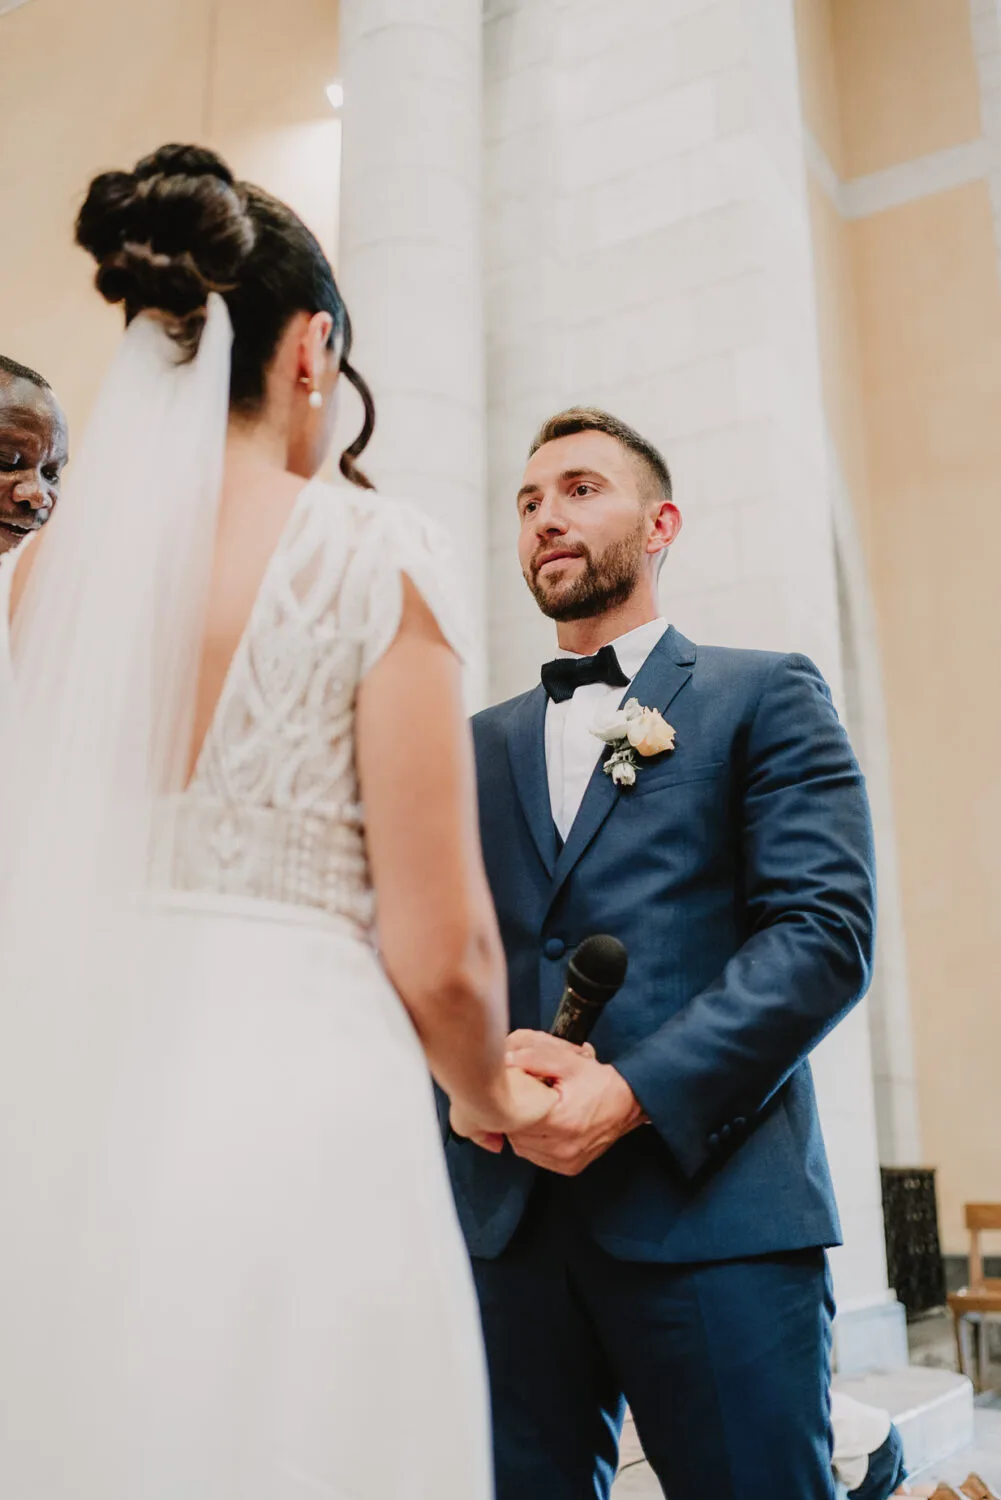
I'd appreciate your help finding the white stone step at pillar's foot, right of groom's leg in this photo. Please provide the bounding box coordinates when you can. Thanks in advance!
[834,1365,972,1473]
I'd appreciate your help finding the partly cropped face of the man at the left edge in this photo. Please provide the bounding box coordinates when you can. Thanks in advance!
[0,371,68,552]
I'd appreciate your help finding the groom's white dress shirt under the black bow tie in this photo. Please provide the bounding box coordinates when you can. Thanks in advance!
[546,620,668,840]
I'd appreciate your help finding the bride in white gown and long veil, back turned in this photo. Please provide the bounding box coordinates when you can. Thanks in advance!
[0,146,554,1500]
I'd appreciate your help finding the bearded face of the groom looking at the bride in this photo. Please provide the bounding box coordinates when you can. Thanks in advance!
[518,432,657,621]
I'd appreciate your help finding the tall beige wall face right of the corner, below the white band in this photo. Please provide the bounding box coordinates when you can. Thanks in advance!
[852,183,1001,1251]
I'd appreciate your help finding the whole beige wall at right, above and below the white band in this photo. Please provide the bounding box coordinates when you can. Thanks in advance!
[797,0,1001,1251]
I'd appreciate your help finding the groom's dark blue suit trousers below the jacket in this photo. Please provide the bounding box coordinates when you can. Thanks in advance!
[473,1175,834,1500]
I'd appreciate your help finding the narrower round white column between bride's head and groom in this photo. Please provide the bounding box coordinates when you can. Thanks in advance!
[339,0,486,701]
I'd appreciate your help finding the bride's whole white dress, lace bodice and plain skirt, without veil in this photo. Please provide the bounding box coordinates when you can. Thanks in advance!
[2,482,492,1500]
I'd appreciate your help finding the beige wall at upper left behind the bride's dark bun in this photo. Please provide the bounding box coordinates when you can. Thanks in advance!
[0,0,339,443]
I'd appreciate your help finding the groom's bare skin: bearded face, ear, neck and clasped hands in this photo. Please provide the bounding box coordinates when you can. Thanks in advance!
[453,432,681,1178]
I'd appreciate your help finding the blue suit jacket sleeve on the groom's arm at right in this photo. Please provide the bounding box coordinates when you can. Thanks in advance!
[615,656,875,1178]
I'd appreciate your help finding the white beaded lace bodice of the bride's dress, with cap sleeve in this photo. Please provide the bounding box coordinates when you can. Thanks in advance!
[152,482,461,939]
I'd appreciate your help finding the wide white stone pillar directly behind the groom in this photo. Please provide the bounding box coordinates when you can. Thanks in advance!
[485,0,906,1368]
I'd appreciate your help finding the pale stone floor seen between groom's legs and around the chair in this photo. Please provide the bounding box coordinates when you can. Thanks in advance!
[612,1313,1001,1500]
